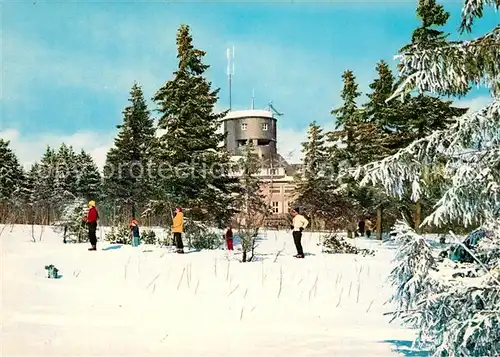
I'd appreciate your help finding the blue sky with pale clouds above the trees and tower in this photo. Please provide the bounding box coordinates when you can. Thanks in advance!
[0,0,498,163]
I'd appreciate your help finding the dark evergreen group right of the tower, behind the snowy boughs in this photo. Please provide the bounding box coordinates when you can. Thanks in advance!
[295,1,467,237]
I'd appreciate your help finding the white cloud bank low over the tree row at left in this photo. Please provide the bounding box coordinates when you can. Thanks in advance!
[0,129,116,169]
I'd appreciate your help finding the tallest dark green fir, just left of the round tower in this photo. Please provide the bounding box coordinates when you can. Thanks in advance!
[153,25,237,222]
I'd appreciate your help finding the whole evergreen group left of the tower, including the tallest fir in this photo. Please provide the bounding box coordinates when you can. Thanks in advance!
[0,25,242,225]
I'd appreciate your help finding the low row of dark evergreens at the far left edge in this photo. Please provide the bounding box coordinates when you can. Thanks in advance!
[0,139,102,224]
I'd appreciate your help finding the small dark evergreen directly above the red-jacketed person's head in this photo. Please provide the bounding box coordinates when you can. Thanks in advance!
[76,150,103,201]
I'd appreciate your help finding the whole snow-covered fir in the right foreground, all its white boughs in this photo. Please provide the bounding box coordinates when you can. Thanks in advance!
[356,0,500,356]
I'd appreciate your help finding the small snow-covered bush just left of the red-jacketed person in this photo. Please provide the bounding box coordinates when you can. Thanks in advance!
[54,198,88,243]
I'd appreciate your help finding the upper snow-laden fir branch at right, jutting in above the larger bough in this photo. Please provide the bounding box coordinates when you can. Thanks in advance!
[387,25,500,101]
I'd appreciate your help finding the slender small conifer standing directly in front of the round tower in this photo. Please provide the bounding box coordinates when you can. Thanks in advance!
[237,140,269,262]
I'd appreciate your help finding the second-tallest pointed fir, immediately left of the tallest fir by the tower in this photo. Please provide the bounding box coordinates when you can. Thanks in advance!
[106,83,155,213]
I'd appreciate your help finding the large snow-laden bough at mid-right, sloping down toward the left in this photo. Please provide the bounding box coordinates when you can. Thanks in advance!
[353,98,500,226]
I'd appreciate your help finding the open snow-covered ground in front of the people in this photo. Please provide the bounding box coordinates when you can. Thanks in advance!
[0,226,421,357]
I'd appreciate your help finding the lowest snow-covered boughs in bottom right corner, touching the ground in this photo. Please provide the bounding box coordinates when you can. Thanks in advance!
[390,223,500,356]
